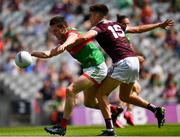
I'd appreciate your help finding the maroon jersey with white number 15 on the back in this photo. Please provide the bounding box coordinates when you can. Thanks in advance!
[92,20,136,62]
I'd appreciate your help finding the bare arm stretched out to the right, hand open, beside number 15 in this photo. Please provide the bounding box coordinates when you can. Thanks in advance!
[127,19,174,33]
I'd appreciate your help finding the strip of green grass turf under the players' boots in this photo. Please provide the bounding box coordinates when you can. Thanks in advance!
[0,124,180,137]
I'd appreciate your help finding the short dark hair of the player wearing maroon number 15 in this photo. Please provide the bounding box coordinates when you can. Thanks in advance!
[89,4,109,16]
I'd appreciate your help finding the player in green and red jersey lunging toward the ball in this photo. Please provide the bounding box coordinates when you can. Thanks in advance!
[31,16,123,135]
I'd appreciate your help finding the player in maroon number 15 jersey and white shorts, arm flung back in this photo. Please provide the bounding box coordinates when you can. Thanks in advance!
[72,4,173,136]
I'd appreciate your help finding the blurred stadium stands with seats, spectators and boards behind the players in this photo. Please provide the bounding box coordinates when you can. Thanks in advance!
[0,0,180,127]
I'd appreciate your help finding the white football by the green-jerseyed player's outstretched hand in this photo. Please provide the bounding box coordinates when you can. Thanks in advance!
[15,51,32,68]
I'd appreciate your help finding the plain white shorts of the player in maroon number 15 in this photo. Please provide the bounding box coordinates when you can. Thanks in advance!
[108,57,140,83]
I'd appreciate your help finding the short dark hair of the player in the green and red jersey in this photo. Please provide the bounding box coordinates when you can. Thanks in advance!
[49,16,68,26]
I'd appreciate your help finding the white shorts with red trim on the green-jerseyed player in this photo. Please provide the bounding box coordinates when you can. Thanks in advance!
[83,62,108,86]
